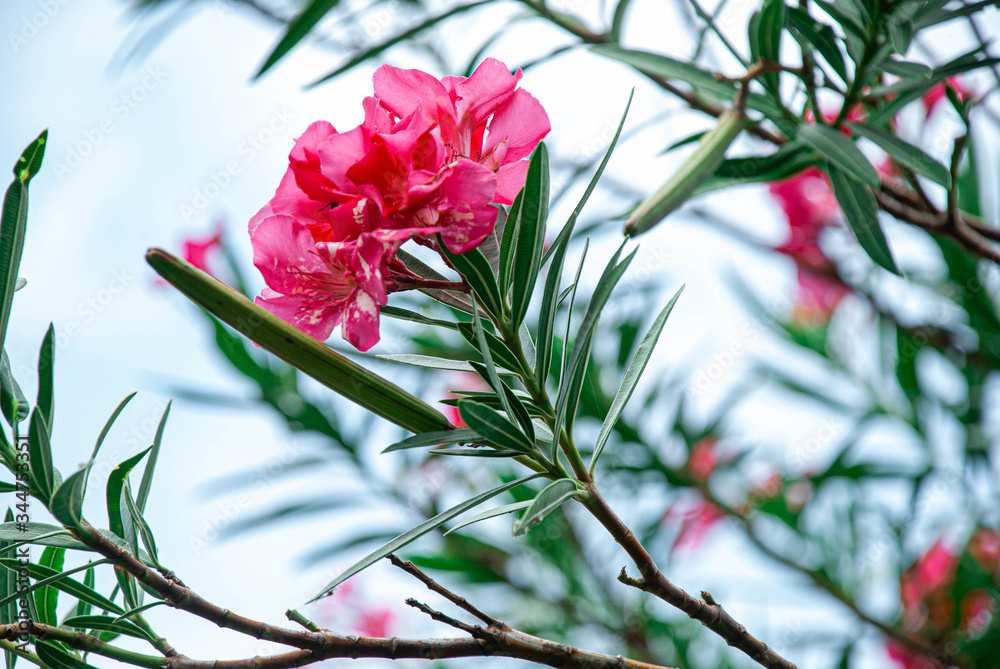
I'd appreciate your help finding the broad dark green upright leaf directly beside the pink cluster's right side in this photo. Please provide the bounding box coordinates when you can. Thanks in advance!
[510,142,549,327]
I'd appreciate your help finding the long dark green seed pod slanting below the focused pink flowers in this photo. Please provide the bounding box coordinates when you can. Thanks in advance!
[146,249,451,432]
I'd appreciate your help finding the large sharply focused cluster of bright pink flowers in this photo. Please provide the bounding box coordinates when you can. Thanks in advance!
[249,58,549,351]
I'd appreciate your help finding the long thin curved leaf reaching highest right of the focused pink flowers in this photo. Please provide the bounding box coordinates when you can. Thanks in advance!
[535,89,635,385]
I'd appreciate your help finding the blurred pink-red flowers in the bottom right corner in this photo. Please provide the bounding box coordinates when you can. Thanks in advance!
[886,527,1000,669]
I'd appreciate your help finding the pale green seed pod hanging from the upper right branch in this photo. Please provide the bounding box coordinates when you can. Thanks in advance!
[625,109,746,237]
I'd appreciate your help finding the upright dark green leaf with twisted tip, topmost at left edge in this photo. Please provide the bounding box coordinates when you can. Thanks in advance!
[0,130,49,350]
